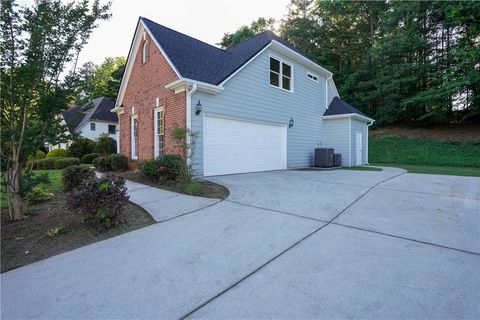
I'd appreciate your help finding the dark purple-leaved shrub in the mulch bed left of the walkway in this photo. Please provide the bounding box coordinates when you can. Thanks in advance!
[67,173,129,229]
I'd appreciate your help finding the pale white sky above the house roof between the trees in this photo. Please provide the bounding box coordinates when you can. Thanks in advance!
[56,0,290,65]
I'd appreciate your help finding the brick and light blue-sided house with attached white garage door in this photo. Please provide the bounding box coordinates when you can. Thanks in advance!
[112,17,373,176]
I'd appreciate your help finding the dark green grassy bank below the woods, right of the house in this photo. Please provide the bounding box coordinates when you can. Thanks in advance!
[368,136,480,168]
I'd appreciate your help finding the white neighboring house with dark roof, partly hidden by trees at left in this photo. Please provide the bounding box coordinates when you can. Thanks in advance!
[48,97,118,150]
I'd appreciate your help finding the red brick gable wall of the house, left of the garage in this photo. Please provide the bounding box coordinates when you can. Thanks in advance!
[119,35,186,166]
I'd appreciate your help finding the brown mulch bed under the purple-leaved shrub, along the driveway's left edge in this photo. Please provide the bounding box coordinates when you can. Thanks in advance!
[1,192,155,272]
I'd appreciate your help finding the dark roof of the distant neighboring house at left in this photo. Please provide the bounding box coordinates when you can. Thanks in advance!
[62,97,118,131]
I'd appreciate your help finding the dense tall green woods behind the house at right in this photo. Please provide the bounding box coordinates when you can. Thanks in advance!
[219,0,480,126]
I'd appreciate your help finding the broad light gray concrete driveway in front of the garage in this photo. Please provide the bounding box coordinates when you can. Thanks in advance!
[1,169,480,319]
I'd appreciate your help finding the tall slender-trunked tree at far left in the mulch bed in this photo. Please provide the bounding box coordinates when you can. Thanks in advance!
[0,0,110,220]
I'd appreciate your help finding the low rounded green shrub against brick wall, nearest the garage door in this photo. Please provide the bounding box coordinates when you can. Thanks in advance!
[140,154,183,181]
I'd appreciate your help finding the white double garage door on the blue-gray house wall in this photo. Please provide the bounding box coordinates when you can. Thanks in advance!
[203,116,287,176]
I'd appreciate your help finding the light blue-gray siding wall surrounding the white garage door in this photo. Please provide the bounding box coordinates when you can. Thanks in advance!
[191,49,326,175]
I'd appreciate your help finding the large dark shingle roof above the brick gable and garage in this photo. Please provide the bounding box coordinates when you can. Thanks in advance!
[140,17,316,85]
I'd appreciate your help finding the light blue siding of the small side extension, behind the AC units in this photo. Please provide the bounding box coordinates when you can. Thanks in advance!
[323,118,351,167]
